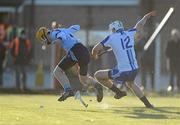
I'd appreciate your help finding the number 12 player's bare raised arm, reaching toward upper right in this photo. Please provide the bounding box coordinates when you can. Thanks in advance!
[134,11,156,41]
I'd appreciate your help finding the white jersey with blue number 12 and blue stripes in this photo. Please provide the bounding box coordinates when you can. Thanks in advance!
[101,28,138,72]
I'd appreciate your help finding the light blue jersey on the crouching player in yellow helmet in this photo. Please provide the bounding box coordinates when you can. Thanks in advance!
[50,25,80,52]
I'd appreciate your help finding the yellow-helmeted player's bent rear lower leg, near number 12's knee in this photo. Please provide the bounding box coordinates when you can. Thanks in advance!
[79,75,103,102]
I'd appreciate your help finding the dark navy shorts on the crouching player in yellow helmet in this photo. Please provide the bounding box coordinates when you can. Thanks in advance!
[59,43,90,76]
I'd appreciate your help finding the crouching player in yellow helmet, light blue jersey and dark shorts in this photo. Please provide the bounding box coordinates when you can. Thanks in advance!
[36,25,103,102]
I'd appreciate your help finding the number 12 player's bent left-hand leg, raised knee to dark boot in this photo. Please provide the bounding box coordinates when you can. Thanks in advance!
[94,70,127,99]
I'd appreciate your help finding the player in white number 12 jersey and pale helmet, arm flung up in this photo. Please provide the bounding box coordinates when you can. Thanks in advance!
[92,11,155,108]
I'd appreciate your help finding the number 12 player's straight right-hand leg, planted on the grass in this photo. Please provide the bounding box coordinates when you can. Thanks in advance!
[127,81,154,108]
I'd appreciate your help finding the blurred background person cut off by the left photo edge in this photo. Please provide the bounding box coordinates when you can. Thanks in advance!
[0,25,6,88]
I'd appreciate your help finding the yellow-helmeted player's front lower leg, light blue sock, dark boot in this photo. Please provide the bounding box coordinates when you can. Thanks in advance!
[53,66,74,101]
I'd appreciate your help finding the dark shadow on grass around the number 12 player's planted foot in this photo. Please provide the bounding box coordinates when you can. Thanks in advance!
[112,107,180,119]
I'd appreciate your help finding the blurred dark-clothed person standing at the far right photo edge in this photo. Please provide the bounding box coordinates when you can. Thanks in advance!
[166,29,180,91]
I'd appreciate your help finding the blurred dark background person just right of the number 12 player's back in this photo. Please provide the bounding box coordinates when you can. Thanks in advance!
[136,30,155,90]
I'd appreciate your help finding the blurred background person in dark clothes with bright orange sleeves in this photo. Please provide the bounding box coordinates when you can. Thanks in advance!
[11,30,31,91]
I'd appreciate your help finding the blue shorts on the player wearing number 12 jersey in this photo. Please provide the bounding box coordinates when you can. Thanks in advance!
[108,69,138,84]
